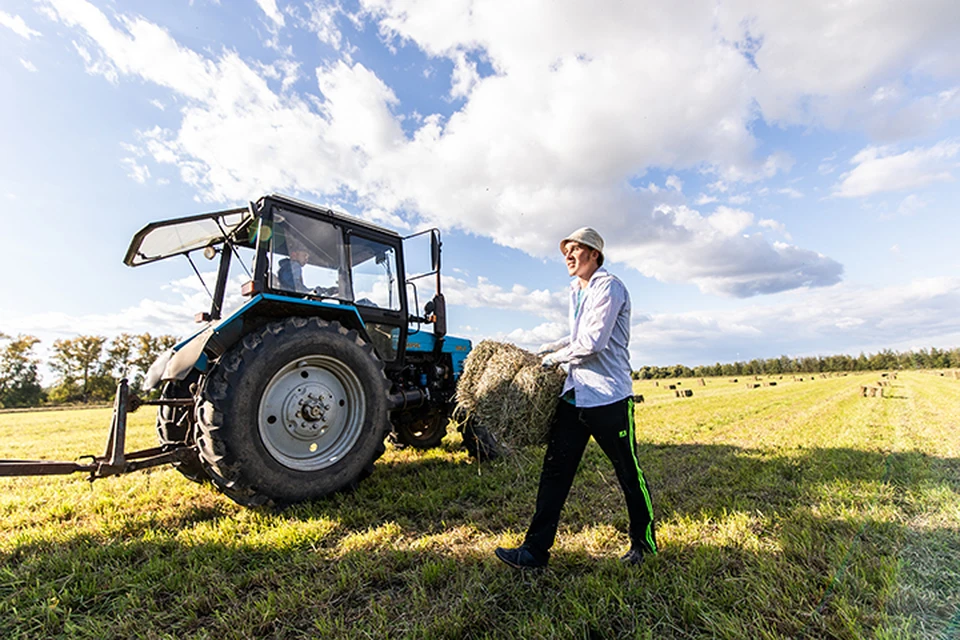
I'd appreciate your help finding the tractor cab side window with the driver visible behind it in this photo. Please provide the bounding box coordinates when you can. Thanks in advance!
[270,209,350,299]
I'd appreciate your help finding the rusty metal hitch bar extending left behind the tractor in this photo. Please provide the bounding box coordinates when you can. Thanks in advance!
[0,378,196,481]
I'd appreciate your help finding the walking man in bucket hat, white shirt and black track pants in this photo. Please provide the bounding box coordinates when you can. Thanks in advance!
[495,227,657,569]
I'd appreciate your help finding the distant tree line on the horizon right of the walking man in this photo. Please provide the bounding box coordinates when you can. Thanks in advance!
[633,347,960,380]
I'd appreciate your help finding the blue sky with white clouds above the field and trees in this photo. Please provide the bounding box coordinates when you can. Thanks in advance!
[0,0,960,380]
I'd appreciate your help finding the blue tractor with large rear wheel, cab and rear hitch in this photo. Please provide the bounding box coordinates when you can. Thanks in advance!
[0,195,471,506]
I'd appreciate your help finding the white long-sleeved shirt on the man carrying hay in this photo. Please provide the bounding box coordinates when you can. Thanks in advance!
[542,267,633,407]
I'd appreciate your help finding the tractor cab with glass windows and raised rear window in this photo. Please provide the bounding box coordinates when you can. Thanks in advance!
[124,195,446,369]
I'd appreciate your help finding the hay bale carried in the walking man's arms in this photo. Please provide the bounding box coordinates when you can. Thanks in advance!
[455,340,565,449]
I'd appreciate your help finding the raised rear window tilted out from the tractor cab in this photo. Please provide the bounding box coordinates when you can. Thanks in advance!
[123,208,253,267]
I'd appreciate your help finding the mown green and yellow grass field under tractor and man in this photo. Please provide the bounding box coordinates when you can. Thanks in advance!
[0,373,960,639]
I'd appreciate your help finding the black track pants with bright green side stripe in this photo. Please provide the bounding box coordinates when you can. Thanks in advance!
[524,398,657,559]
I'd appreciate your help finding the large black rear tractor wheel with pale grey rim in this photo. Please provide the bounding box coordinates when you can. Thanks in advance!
[197,317,388,506]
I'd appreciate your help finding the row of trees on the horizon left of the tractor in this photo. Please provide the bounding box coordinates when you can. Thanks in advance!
[0,333,177,408]
